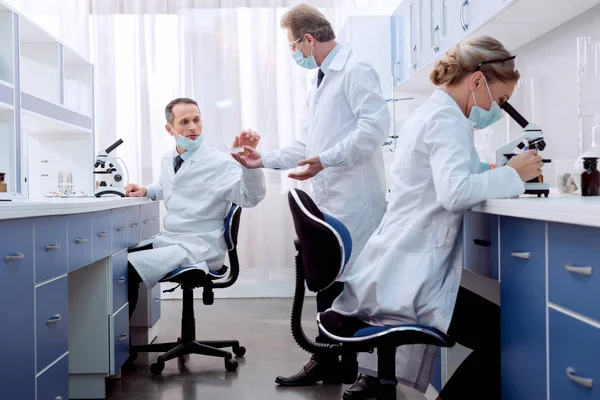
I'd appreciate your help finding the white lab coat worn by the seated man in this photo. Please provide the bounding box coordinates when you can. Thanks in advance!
[128,143,266,288]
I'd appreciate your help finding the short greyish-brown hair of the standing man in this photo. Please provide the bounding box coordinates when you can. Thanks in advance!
[281,4,335,42]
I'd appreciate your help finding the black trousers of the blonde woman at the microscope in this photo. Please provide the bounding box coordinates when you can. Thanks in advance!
[440,287,500,400]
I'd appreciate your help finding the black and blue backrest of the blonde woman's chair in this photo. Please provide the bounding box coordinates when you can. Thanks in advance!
[288,189,352,292]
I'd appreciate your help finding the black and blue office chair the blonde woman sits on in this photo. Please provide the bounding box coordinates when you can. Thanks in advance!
[288,189,454,400]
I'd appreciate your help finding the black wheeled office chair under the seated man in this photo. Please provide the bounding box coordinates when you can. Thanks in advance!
[131,204,246,375]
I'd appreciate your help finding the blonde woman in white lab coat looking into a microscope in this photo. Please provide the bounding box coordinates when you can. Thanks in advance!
[322,37,543,400]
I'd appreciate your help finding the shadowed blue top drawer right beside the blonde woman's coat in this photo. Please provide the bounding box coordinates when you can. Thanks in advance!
[464,212,499,280]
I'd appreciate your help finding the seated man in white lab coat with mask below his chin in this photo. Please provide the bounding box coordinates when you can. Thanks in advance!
[125,98,266,316]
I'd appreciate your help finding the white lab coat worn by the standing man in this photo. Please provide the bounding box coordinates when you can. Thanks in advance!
[262,45,391,281]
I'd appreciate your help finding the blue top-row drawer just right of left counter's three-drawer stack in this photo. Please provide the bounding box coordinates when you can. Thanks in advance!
[67,214,92,271]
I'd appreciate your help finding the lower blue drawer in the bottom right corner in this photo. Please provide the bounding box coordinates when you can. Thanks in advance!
[550,309,600,400]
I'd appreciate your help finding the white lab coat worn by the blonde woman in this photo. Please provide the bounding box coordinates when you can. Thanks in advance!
[332,90,525,392]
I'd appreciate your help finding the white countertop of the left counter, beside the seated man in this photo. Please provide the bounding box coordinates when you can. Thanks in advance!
[0,197,152,220]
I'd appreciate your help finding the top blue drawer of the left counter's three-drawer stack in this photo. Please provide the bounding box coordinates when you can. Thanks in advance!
[34,216,67,283]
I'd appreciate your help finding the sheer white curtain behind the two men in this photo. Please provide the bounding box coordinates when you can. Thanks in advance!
[90,0,344,297]
